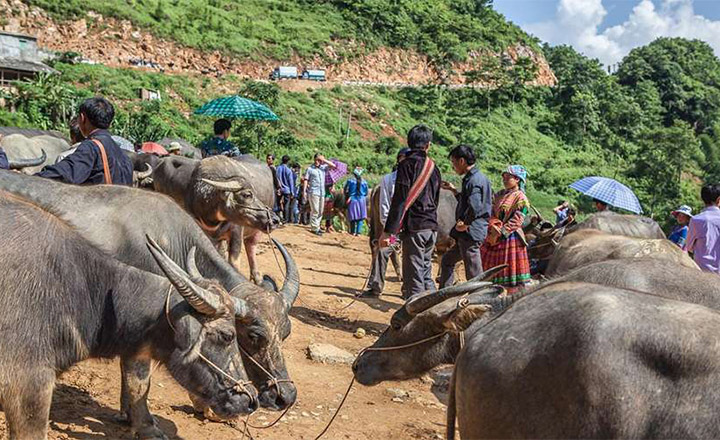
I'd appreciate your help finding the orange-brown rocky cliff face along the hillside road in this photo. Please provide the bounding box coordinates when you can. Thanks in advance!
[0,0,556,86]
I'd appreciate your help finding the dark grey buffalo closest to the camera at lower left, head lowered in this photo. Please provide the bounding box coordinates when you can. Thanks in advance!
[0,192,256,440]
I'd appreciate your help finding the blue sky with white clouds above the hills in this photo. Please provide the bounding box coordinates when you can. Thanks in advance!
[493,0,720,65]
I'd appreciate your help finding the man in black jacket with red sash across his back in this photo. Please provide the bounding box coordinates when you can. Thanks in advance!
[379,124,441,299]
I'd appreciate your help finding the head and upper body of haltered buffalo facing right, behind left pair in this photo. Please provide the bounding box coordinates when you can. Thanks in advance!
[187,156,280,231]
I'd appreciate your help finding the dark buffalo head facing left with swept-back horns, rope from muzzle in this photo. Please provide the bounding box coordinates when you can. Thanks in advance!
[353,266,505,385]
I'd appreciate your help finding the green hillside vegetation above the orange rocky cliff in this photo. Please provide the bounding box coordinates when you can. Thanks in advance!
[25,0,534,67]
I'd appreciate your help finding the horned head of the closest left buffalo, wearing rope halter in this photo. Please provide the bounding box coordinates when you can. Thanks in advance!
[147,237,257,419]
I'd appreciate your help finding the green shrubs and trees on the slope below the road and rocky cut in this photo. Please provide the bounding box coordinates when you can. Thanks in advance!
[0,35,720,227]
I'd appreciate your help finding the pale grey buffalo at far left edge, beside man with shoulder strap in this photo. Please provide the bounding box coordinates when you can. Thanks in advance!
[0,128,70,174]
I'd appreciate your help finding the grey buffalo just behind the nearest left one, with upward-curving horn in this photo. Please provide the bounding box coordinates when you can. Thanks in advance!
[0,172,300,408]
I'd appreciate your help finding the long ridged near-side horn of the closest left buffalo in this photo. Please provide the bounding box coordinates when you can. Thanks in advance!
[145,235,222,316]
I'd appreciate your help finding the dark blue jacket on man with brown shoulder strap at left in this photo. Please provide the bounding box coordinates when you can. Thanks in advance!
[35,130,132,186]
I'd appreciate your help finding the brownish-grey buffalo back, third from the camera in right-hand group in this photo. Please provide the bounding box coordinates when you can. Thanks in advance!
[545,229,699,277]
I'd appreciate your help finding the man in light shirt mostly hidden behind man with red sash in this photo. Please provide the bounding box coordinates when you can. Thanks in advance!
[361,148,410,298]
